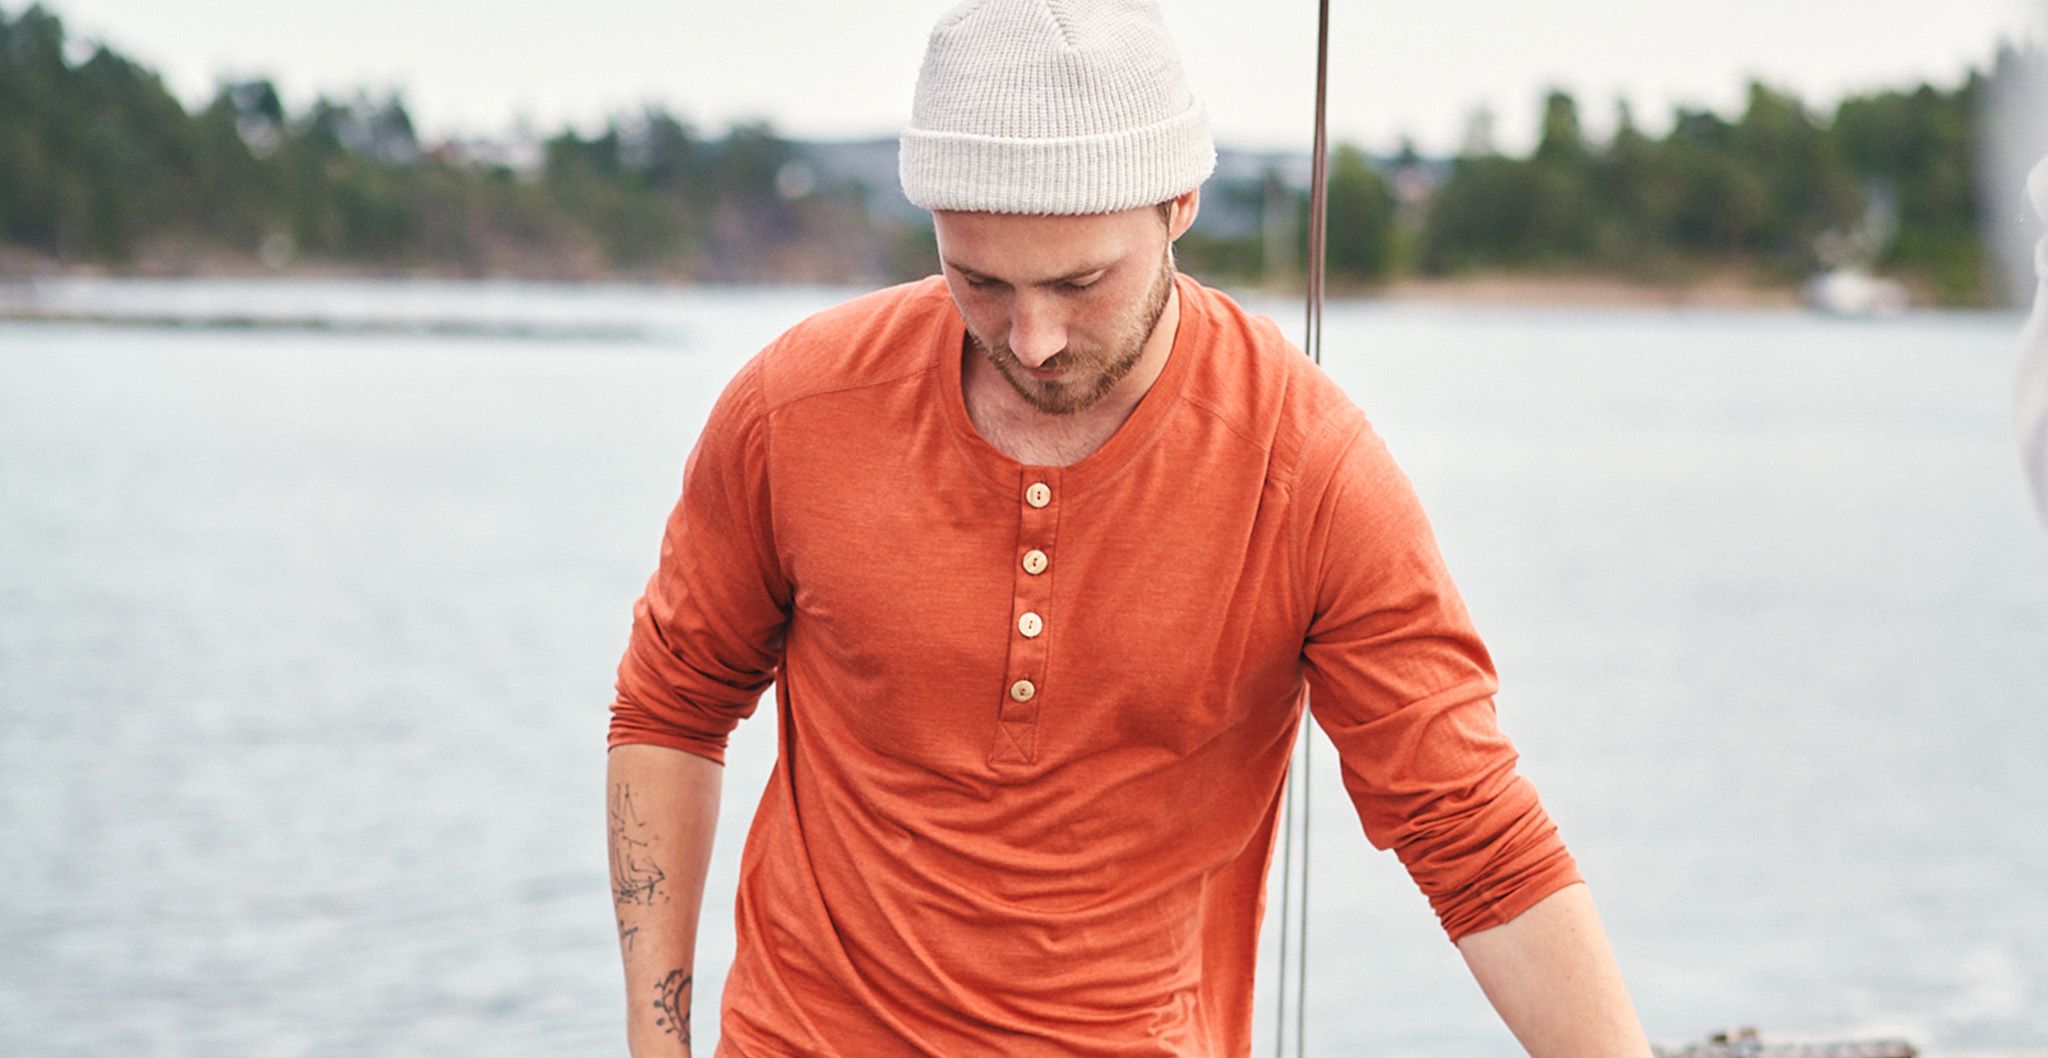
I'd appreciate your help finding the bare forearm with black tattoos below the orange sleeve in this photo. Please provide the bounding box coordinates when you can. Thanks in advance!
[604,745,725,1058]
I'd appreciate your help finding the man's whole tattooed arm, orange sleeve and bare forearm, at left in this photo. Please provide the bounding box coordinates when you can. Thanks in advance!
[606,358,793,1058]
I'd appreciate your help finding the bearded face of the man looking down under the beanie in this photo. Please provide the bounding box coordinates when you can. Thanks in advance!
[932,207,1176,415]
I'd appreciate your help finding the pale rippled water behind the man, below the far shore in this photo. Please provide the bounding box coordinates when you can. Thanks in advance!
[0,282,2048,1058]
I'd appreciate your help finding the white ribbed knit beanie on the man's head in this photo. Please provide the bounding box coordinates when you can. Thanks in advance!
[897,0,1217,215]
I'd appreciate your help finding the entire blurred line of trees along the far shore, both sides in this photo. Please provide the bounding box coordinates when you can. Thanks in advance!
[0,6,2040,305]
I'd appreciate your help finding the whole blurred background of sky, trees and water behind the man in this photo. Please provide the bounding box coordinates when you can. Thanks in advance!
[0,0,2048,1058]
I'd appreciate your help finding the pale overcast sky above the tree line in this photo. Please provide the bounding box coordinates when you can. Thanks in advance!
[19,0,2048,153]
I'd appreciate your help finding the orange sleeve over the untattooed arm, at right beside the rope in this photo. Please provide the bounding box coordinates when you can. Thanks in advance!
[1303,411,1579,939]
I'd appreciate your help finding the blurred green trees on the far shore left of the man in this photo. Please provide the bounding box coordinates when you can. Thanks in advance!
[0,6,856,278]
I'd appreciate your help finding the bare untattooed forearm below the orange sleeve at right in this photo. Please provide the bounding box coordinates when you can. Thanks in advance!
[1458,884,1651,1058]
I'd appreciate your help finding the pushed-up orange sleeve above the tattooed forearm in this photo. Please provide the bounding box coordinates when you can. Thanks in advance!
[610,360,791,761]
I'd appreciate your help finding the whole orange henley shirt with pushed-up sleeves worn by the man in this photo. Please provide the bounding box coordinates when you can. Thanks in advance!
[610,278,1579,1058]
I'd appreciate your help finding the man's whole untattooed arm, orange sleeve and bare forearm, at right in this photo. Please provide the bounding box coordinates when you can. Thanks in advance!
[1303,411,1651,1058]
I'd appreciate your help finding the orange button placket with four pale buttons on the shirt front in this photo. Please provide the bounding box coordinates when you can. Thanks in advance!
[989,467,1061,763]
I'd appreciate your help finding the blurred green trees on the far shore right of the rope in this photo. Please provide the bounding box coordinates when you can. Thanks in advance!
[1421,78,1987,305]
